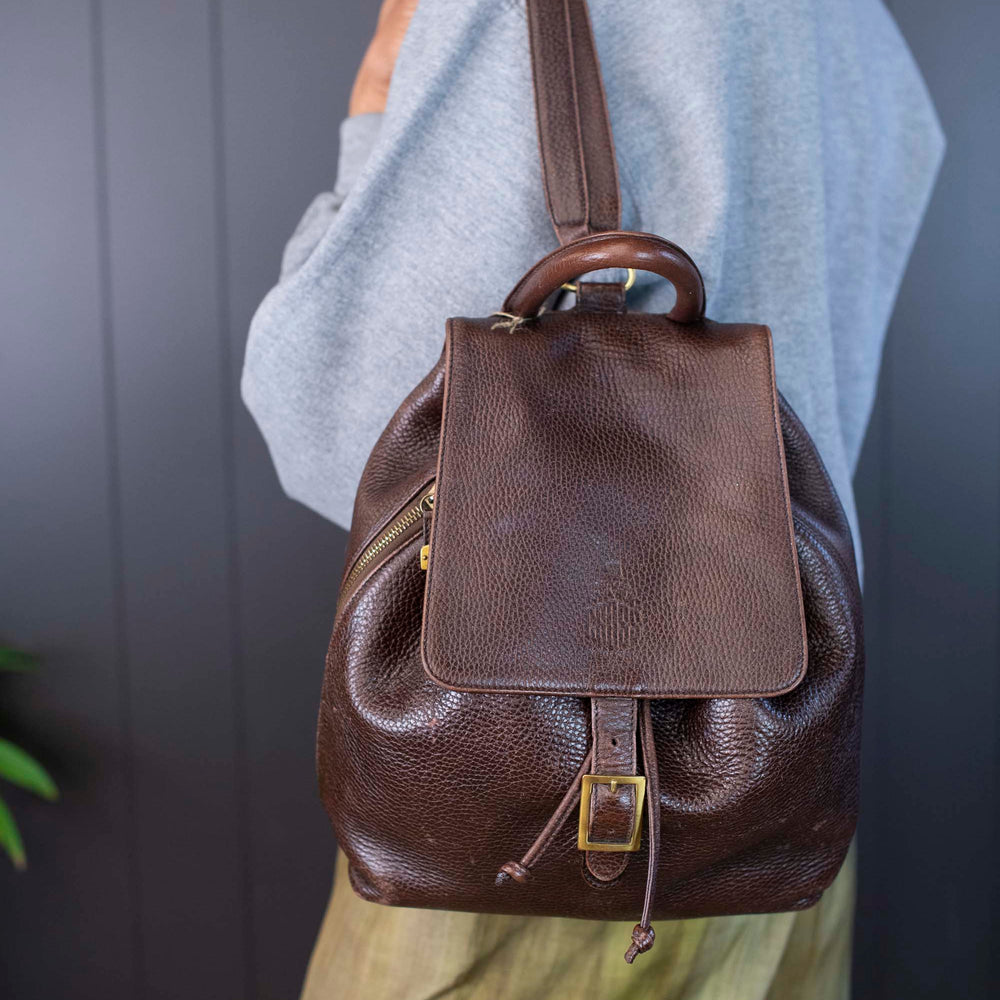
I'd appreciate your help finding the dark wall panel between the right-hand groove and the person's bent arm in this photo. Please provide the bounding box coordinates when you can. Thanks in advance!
[221,0,377,1000]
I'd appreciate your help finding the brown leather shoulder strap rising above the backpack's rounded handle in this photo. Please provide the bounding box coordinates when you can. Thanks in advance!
[527,0,621,243]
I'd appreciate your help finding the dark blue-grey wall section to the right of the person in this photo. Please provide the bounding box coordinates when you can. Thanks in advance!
[859,0,1000,998]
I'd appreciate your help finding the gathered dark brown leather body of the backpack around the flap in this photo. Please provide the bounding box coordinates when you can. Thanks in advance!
[317,362,864,920]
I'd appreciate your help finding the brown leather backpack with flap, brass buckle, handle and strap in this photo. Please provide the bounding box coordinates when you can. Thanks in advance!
[318,0,864,961]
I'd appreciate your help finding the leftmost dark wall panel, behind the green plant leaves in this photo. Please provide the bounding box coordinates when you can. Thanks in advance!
[0,0,139,1000]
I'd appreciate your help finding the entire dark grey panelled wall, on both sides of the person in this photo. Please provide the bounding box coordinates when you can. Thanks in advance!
[0,0,1000,1000]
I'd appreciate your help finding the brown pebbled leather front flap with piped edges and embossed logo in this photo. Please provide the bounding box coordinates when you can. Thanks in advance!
[422,310,806,698]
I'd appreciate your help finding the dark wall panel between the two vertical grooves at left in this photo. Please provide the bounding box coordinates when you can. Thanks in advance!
[97,0,246,1000]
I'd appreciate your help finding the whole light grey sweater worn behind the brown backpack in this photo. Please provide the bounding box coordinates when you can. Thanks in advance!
[243,0,944,580]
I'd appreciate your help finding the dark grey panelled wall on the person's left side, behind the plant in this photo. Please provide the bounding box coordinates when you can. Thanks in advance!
[0,0,375,1000]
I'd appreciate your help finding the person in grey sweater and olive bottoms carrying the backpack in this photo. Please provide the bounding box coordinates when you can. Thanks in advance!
[242,0,944,1000]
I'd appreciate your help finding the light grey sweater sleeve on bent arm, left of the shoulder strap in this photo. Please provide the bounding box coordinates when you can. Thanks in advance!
[240,0,536,528]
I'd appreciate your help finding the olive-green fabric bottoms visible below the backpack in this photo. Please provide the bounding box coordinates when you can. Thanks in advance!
[302,848,855,1000]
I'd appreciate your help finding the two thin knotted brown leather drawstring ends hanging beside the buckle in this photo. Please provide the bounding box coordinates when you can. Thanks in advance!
[496,700,660,965]
